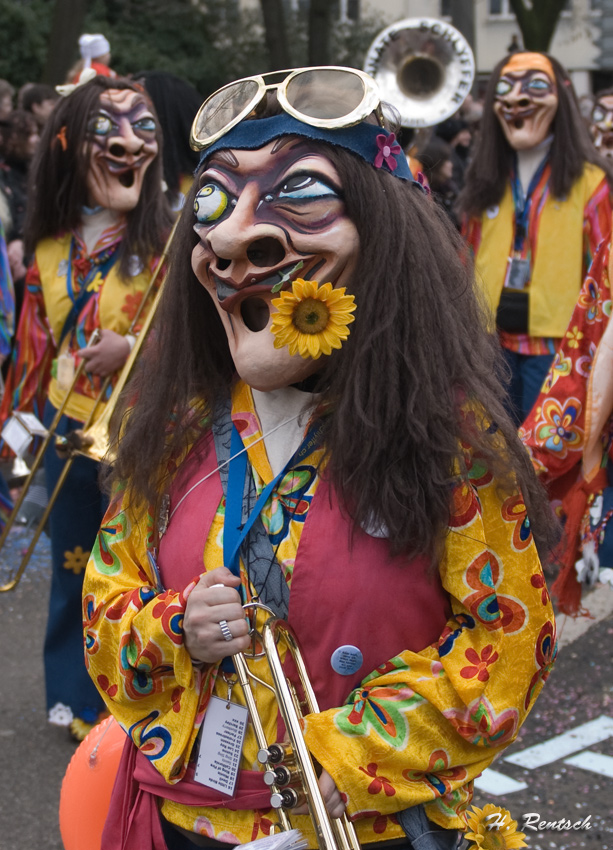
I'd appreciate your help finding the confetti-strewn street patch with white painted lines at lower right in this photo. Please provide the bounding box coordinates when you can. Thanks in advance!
[474,586,613,850]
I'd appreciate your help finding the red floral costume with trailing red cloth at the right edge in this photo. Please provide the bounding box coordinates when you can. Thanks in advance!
[520,235,613,613]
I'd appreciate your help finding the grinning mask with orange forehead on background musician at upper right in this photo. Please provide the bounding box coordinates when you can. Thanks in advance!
[494,53,558,151]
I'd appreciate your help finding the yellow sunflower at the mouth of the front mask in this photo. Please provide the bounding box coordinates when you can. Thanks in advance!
[270,278,356,360]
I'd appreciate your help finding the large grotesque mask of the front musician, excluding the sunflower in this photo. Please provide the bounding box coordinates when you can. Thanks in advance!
[192,136,359,391]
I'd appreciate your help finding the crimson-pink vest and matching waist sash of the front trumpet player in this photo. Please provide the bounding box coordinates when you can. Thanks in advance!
[102,434,450,850]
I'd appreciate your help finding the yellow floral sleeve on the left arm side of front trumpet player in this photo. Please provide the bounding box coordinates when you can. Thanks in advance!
[83,484,213,782]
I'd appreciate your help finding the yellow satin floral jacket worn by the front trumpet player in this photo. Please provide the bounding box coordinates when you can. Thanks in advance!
[84,384,556,846]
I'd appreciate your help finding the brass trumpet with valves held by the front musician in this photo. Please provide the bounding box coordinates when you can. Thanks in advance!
[232,603,360,850]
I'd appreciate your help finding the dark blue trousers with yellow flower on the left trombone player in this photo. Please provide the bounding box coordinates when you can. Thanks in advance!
[43,402,107,723]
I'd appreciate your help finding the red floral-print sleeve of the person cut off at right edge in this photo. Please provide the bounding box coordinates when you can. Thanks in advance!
[520,241,611,486]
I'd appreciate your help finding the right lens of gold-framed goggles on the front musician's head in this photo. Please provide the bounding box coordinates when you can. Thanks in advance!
[285,68,366,120]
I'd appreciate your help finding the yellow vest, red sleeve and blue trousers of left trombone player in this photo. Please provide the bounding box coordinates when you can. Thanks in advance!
[2,224,160,725]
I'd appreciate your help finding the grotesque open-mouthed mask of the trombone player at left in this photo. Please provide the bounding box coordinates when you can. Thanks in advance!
[87,89,158,212]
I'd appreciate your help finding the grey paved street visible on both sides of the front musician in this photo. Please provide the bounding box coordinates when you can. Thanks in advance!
[0,531,613,850]
